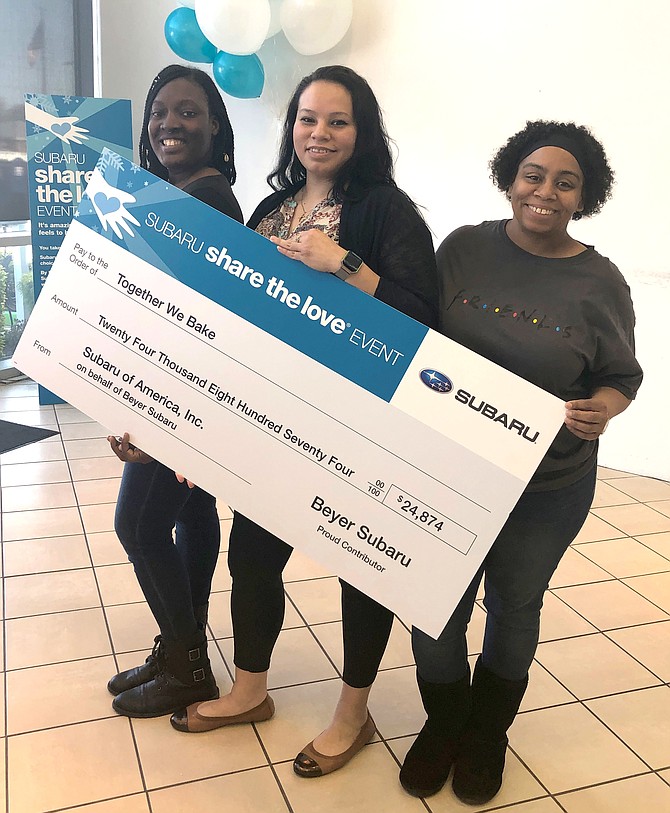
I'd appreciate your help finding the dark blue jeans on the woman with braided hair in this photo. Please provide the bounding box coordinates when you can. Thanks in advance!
[114,460,221,641]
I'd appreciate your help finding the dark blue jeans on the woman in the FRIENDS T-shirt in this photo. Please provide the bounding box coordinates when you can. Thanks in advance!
[412,466,596,683]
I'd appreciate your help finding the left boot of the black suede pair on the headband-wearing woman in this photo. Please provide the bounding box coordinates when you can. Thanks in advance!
[400,669,470,796]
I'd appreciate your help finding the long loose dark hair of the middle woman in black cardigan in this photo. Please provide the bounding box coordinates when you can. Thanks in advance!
[267,65,396,200]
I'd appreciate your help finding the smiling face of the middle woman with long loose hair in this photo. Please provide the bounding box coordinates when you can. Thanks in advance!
[293,80,356,181]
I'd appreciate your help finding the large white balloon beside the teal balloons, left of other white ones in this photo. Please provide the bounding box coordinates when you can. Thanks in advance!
[195,0,270,56]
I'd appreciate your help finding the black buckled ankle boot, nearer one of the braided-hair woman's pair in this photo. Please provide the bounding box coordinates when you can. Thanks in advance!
[112,631,219,717]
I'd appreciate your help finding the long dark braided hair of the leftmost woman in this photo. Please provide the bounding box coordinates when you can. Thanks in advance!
[139,65,237,186]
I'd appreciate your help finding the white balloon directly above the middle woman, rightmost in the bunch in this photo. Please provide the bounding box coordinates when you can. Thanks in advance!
[280,0,354,55]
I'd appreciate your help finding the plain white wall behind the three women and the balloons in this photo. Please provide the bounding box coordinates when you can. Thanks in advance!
[100,0,670,479]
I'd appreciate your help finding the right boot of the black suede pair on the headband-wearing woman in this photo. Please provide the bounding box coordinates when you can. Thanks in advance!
[452,658,528,805]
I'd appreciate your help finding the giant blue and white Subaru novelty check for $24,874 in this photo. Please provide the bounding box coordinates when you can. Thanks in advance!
[15,152,564,636]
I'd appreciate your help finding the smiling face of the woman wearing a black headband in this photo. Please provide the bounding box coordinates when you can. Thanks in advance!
[508,147,584,241]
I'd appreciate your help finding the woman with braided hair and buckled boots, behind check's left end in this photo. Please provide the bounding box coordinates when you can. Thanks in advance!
[103,65,242,717]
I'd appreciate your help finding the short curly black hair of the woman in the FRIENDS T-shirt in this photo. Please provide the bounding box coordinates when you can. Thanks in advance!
[489,121,614,220]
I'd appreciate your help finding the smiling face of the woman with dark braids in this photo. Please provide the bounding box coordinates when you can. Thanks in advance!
[148,78,219,185]
